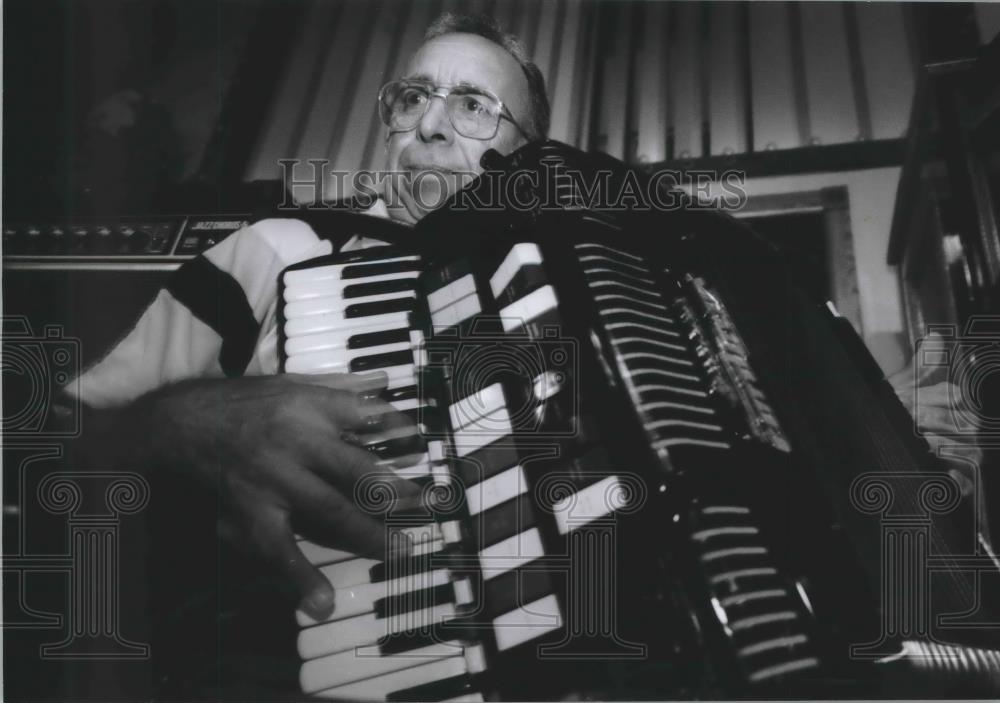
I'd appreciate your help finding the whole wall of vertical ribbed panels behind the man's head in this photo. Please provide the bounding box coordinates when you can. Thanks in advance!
[246,0,920,179]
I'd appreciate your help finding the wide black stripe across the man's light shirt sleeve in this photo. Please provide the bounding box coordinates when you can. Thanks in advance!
[167,256,260,378]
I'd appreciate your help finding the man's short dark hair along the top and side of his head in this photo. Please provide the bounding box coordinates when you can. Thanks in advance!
[424,12,551,139]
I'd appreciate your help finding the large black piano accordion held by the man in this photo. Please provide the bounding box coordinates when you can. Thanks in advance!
[279,142,1000,700]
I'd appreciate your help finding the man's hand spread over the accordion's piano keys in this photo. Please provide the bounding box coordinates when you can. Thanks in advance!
[125,374,417,618]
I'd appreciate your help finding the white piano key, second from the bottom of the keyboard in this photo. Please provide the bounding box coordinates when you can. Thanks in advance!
[299,642,462,694]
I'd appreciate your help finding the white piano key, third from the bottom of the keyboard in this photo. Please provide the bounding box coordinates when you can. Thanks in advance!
[298,603,455,660]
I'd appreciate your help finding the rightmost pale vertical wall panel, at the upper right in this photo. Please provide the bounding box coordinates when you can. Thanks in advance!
[856,3,914,139]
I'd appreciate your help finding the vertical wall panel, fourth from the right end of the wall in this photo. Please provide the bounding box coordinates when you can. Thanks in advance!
[708,2,747,155]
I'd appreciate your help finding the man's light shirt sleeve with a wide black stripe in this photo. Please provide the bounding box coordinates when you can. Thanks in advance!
[67,219,332,408]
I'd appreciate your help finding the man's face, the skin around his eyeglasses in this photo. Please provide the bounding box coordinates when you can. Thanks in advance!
[386,34,529,224]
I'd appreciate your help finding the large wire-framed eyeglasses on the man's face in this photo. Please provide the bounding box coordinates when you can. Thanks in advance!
[378,80,528,139]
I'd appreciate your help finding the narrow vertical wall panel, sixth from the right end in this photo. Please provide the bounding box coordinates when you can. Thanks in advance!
[632,2,670,163]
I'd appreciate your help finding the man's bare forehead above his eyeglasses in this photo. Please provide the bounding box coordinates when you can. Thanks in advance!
[405,33,521,92]
